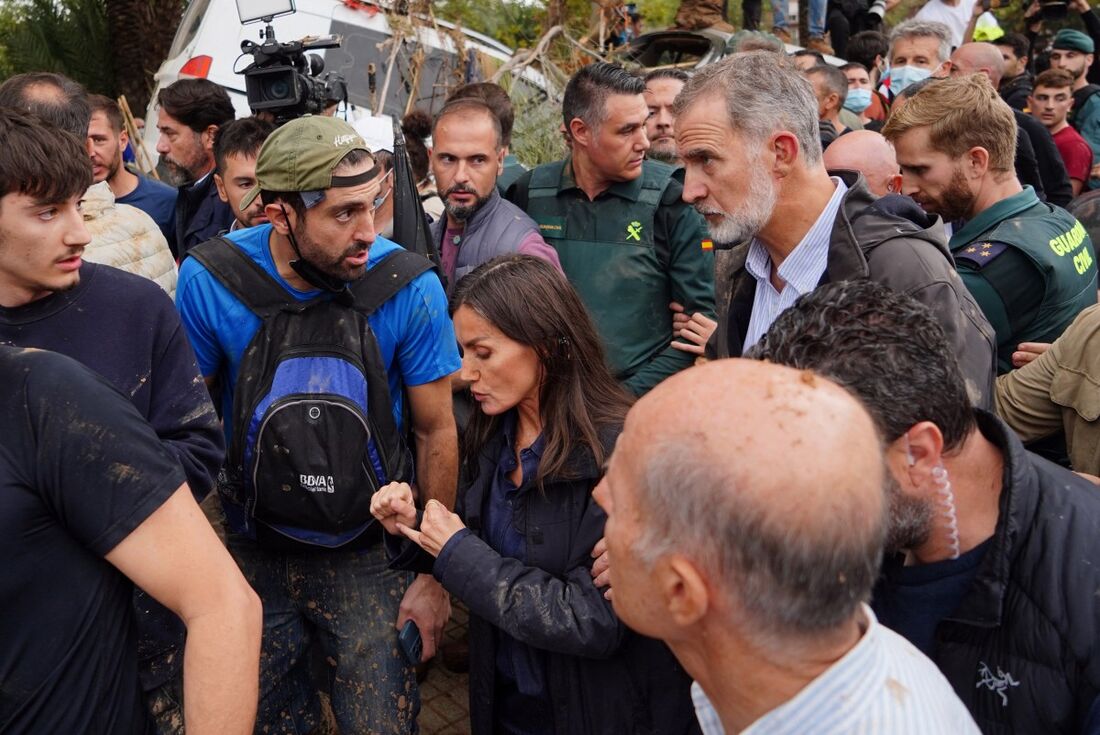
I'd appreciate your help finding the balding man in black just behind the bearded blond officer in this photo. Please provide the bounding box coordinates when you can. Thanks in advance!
[944,43,1074,207]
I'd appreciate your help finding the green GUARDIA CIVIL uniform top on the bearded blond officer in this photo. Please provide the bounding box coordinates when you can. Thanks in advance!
[950,187,1097,374]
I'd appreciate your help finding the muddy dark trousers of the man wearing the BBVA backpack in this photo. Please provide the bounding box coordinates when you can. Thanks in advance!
[228,536,420,735]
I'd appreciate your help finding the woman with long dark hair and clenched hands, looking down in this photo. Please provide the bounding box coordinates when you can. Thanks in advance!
[372,255,695,735]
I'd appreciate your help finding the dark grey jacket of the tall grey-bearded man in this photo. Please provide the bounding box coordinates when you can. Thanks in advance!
[708,171,997,408]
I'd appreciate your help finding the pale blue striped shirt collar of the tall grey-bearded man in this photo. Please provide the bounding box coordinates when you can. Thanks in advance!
[743,176,848,352]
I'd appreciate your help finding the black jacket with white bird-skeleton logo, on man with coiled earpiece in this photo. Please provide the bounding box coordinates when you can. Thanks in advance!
[884,413,1100,735]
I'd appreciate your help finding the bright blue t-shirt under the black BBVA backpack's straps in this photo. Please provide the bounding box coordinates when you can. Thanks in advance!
[176,224,462,442]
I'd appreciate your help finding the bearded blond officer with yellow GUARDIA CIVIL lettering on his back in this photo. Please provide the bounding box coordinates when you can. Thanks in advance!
[882,75,1097,373]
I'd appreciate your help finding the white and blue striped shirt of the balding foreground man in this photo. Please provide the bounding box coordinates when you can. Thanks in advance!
[691,605,979,735]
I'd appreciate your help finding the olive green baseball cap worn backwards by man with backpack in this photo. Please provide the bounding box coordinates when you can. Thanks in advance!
[240,114,381,211]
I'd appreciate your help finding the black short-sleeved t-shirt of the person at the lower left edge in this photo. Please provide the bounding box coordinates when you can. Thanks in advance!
[0,347,184,735]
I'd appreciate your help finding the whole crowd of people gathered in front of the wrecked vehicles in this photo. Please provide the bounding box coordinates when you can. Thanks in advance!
[0,0,1100,735]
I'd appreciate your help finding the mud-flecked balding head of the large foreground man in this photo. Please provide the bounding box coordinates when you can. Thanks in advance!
[597,360,884,639]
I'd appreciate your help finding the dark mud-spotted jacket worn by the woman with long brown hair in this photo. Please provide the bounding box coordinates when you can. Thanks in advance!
[387,431,700,735]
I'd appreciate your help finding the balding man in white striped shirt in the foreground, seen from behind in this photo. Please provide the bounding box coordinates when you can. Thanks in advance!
[596,359,978,735]
